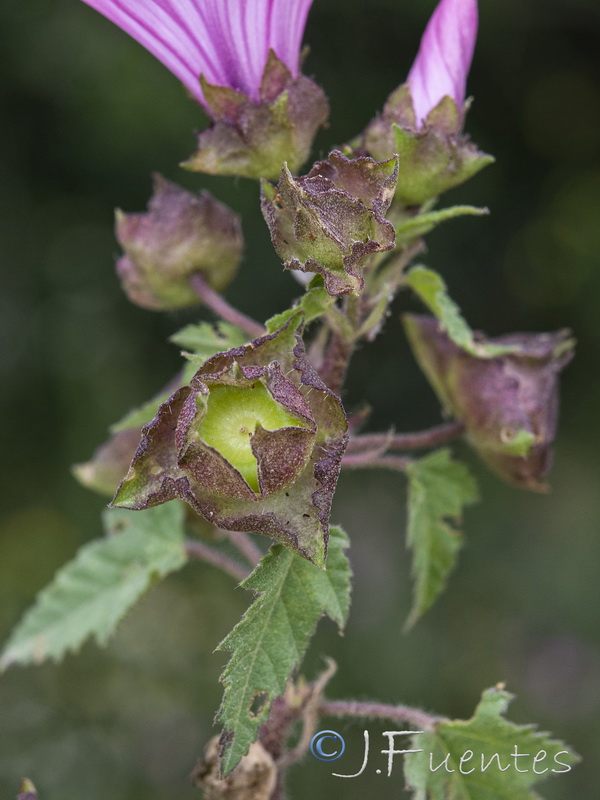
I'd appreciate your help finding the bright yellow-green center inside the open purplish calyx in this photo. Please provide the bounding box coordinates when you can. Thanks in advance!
[198,381,305,492]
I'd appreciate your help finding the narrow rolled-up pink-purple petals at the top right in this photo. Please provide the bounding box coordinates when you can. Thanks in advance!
[407,0,477,126]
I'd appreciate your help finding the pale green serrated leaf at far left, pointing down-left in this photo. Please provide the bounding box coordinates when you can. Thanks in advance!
[0,503,187,670]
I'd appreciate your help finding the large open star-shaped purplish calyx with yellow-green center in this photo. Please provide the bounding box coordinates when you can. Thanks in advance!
[113,315,347,566]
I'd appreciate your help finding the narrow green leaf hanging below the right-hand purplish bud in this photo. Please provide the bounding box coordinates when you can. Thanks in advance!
[406,449,478,628]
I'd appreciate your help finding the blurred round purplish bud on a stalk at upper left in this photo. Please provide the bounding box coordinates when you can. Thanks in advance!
[116,175,243,311]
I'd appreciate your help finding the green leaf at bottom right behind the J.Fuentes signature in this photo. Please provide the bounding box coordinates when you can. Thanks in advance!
[404,688,580,800]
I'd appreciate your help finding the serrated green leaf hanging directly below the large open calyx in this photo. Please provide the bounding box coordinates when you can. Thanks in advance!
[218,528,351,776]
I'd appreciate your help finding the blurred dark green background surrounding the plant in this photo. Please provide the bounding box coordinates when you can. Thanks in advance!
[0,0,600,800]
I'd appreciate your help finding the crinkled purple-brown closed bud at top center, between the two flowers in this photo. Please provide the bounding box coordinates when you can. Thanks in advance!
[262,150,398,295]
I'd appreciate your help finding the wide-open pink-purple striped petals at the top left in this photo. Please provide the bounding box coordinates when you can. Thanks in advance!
[83,0,312,105]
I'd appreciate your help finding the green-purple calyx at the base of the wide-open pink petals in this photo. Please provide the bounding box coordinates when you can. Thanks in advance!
[182,51,329,179]
